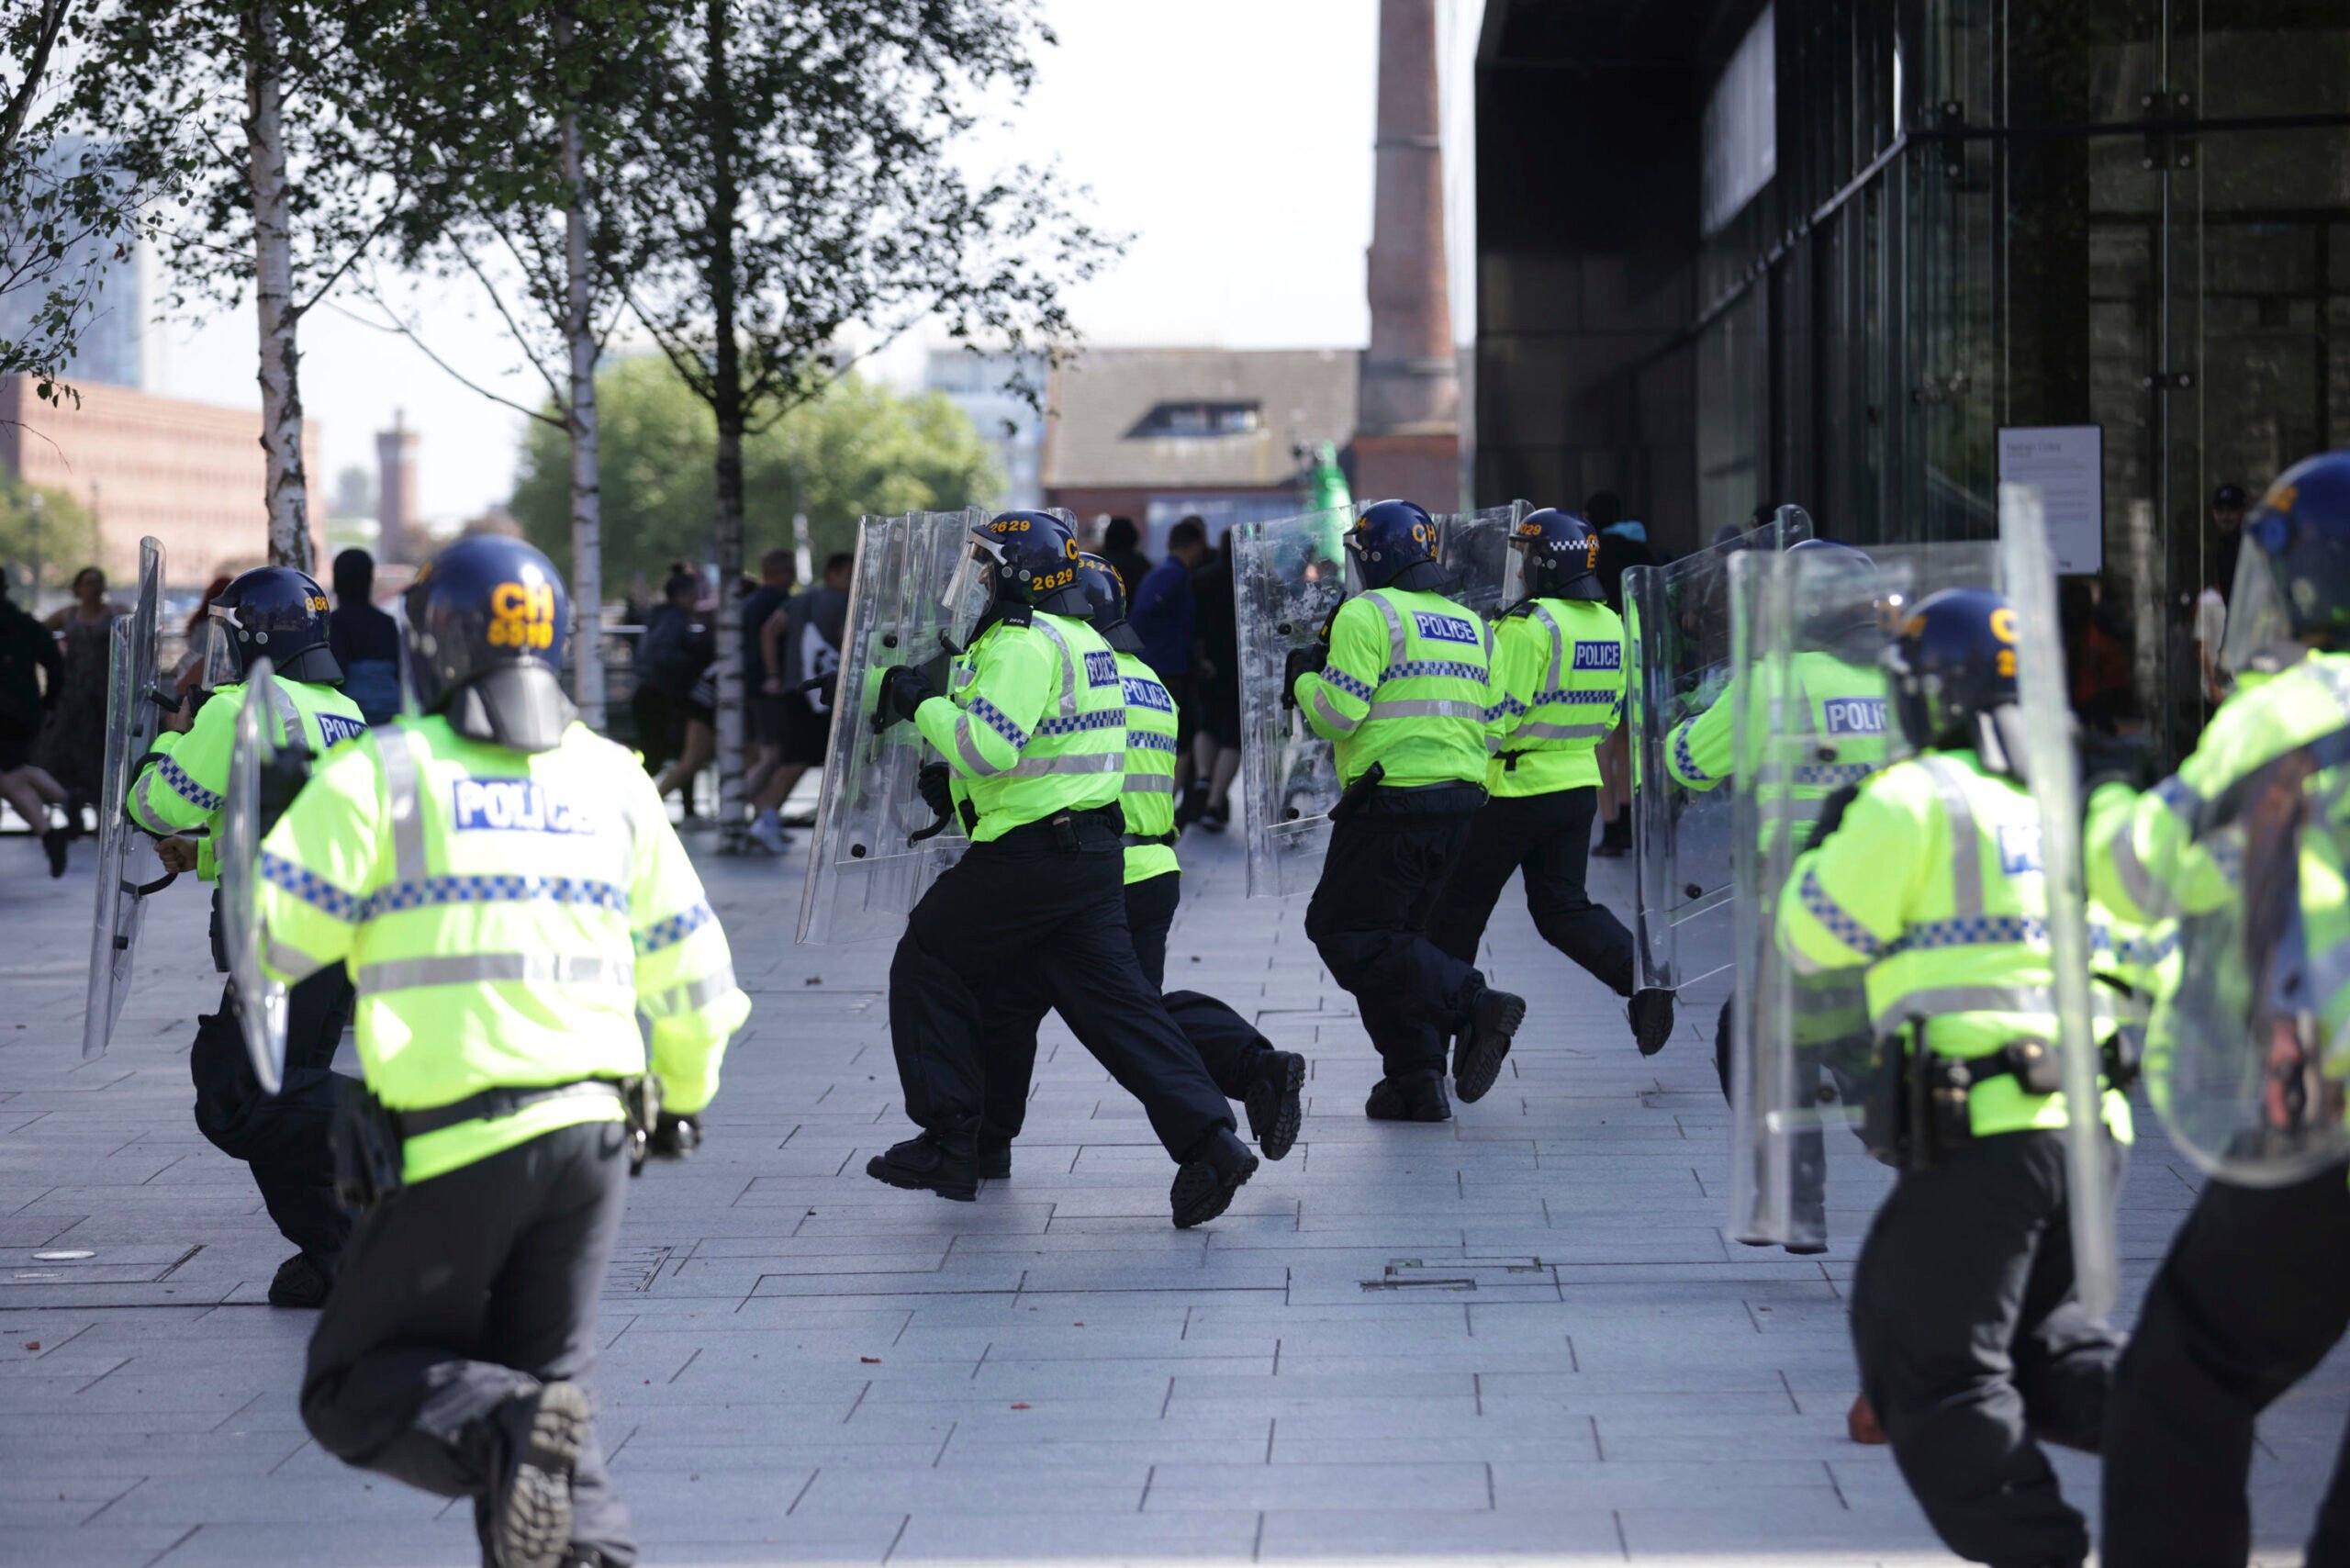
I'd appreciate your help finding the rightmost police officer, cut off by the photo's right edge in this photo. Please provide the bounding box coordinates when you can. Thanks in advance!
[2087,452,2350,1568]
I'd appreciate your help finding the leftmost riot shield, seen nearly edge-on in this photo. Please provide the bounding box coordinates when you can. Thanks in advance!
[83,538,172,1058]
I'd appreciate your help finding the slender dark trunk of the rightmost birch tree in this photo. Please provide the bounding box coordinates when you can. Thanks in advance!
[705,0,745,848]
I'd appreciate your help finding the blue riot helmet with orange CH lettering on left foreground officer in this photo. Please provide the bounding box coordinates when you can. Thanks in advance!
[402,536,576,752]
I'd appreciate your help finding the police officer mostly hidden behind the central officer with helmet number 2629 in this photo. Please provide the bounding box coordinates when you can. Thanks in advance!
[968,554,1306,1178]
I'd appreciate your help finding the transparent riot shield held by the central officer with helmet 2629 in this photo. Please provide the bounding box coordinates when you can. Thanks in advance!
[799,508,987,945]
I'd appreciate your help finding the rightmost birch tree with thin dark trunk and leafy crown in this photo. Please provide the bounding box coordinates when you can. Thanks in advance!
[616,0,1113,832]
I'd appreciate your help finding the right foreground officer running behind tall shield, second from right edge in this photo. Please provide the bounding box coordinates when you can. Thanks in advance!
[1779,588,2129,1568]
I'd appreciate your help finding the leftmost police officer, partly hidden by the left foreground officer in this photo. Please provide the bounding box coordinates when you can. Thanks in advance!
[127,566,366,1307]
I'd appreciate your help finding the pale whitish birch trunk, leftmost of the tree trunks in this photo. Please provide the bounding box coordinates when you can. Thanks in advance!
[244,0,318,571]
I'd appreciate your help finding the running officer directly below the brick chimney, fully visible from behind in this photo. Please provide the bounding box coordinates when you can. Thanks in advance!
[1283,500,1525,1121]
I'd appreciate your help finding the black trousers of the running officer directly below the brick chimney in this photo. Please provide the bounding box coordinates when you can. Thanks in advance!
[1306,785,1485,1077]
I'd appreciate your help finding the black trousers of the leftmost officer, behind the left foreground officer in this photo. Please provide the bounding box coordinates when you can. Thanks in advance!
[188,905,357,1260]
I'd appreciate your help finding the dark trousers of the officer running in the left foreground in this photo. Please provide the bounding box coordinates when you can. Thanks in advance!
[301,1121,637,1568]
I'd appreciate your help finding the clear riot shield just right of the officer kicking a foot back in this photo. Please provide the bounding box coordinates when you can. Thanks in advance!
[1624,506,1812,990]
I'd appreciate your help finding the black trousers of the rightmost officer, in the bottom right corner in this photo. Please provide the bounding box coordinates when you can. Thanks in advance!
[2103,1164,2350,1568]
